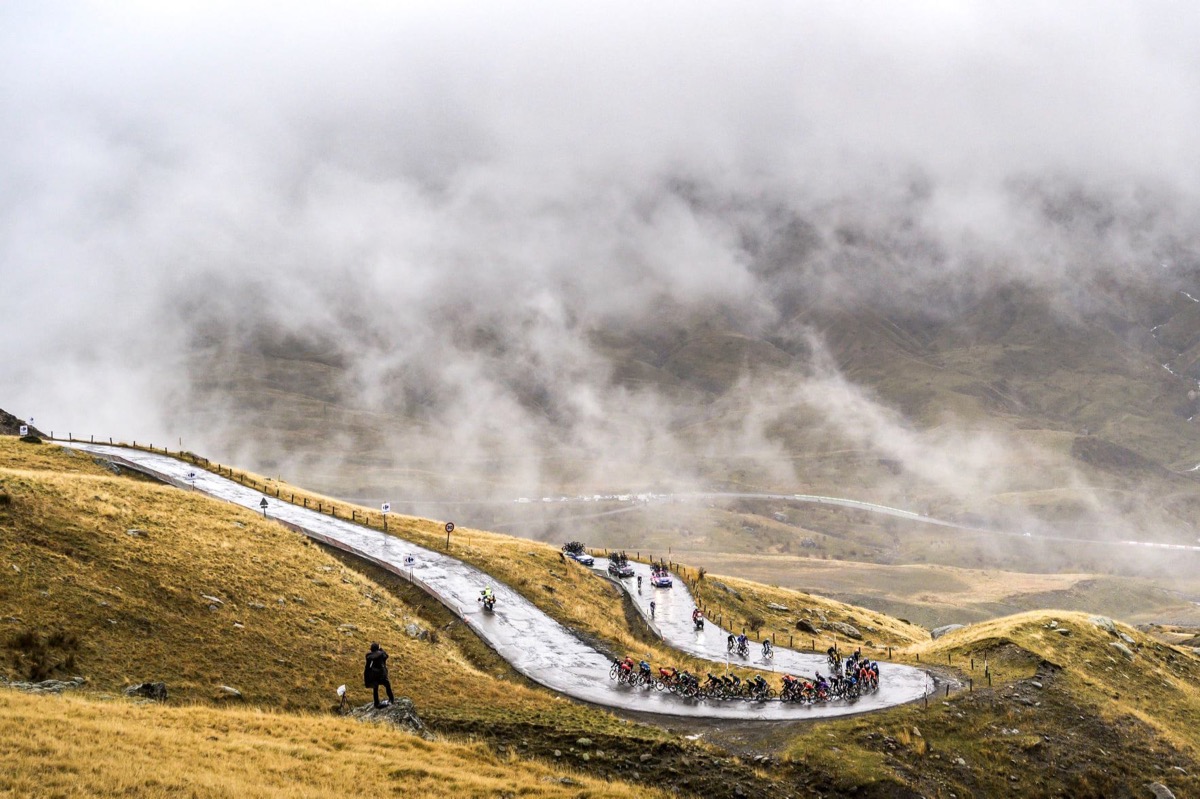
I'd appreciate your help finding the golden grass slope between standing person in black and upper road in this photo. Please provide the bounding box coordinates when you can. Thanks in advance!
[0,438,609,720]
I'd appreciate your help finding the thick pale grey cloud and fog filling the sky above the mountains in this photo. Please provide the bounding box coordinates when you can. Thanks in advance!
[0,0,1200,494]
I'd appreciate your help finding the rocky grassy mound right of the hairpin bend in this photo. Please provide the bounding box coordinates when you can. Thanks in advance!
[761,611,1200,797]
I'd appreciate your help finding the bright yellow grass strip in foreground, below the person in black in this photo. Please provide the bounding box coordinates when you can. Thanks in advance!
[0,691,665,799]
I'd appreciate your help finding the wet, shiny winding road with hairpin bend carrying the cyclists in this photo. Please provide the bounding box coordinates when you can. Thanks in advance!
[62,441,932,721]
